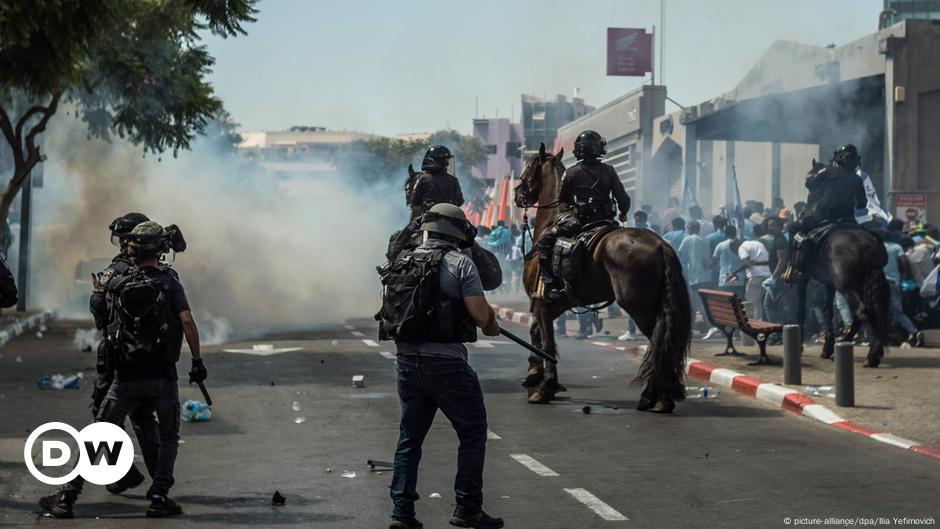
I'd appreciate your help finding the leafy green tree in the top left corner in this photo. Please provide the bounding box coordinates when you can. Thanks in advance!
[0,0,257,227]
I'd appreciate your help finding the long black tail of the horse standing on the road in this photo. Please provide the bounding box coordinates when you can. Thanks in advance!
[636,243,692,400]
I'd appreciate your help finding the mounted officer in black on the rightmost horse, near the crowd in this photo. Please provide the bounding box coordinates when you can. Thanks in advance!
[785,144,868,281]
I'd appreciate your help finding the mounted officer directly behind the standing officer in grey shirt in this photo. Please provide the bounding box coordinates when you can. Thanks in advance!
[386,145,464,261]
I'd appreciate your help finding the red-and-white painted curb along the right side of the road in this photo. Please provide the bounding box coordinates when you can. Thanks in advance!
[492,305,940,459]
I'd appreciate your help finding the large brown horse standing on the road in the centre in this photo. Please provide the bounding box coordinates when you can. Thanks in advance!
[515,144,692,413]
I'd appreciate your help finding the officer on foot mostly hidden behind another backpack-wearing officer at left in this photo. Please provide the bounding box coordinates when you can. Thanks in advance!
[39,212,159,518]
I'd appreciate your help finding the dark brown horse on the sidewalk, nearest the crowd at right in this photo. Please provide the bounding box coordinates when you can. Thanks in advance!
[797,160,891,367]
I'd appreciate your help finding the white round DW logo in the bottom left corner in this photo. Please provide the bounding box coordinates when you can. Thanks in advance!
[23,422,134,485]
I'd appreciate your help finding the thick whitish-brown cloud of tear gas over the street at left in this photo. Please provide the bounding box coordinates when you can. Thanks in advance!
[31,116,406,342]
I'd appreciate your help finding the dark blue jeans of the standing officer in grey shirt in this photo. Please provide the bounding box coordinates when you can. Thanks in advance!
[391,355,486,519]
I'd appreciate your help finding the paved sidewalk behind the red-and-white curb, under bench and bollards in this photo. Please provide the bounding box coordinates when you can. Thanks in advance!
[488,297,940,454]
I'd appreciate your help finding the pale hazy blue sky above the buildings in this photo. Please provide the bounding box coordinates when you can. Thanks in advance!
[207,0,882,135]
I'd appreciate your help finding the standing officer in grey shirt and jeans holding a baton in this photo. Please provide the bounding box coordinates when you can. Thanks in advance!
[379,203,503,529]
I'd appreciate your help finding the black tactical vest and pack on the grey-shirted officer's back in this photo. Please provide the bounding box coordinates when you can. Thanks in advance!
[375,248,477,343]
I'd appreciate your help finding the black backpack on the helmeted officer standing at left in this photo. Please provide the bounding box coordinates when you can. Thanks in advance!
[109,267,179,364]
